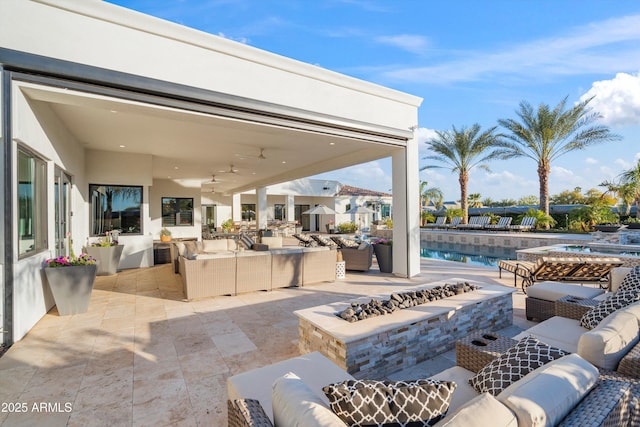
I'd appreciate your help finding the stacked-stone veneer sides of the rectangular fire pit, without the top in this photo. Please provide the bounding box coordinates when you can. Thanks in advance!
[298,293,513,379]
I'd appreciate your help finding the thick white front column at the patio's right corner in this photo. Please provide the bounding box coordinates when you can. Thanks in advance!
[392,138,420,277]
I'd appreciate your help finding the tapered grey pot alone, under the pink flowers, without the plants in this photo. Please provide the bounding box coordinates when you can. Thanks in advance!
[44,264,98,316]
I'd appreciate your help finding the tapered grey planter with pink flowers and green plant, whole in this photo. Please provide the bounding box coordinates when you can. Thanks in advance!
[44,236,98,316]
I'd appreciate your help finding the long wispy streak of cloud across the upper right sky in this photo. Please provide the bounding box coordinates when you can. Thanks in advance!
[382,15,640,84]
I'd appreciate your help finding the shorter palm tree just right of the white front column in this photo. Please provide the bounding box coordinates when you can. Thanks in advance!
[420,123,506,224]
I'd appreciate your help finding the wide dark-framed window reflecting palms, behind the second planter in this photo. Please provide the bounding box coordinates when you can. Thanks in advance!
[89,184,142,236]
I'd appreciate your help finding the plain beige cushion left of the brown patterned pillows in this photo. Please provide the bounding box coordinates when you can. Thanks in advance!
[272,372,345,427]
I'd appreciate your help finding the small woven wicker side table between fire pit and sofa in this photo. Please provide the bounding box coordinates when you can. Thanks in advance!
[456,331,518,372]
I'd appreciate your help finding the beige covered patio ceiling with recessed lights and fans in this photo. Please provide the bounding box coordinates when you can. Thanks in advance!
[23,85,405,194]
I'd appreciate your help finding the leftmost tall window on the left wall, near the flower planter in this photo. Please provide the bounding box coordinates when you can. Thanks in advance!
[18,149,47,257]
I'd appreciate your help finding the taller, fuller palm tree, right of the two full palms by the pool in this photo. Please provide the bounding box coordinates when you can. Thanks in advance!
[498,97,620,214]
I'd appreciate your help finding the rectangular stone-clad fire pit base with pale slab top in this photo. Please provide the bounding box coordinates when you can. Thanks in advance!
[295,279,515,379]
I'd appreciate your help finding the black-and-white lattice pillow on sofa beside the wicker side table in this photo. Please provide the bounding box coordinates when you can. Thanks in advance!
[469,335,569,396]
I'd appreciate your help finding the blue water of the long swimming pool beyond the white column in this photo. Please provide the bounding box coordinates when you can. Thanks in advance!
[420,243,516,267]
